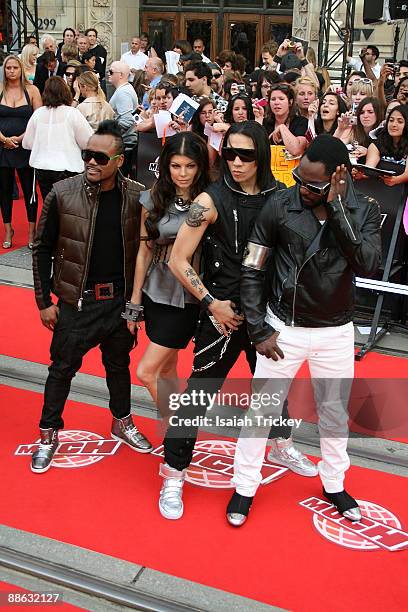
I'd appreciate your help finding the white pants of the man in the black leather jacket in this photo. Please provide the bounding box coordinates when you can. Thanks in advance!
[233,312,354,497]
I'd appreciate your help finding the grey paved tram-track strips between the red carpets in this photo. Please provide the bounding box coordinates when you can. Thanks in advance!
[0,248,408,612]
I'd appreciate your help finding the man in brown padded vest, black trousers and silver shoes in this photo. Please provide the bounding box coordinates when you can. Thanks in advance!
[31,121,152,473]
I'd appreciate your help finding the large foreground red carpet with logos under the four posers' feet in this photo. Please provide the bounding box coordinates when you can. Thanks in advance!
[0,388,408,612]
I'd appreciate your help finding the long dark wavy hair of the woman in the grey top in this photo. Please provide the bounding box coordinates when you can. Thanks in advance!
[145,132,210,240]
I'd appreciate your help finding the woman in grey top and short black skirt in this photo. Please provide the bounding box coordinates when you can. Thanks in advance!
[128,132,209,414]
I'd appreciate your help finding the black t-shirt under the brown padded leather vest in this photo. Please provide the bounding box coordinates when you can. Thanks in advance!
[87,187,124,285]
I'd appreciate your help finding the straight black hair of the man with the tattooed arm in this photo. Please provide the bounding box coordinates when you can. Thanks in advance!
[222,121,273,191]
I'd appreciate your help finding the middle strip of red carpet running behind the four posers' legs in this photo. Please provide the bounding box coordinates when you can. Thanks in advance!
[0,284,408,384]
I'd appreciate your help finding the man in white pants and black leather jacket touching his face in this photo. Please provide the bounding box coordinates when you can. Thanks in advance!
[227,135,381,527]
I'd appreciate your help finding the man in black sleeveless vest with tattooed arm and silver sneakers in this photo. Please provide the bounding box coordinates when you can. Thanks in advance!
[159,121,317,519]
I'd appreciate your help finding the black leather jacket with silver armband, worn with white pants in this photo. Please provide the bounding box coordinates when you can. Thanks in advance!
[241,179,381,343]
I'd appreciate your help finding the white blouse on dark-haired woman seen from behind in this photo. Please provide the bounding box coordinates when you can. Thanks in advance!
[22,105,93,173]
